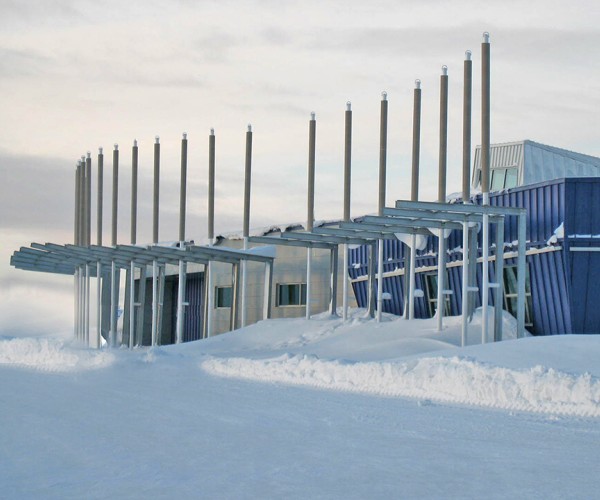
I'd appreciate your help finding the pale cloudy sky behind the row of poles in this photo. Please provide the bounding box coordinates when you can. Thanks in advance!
[0,0,600,335]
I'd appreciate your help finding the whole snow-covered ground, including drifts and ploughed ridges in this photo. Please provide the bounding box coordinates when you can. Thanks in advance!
[0,311,600,498]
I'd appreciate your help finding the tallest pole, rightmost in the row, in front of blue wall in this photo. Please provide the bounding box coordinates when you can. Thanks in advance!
[481,32,490,344]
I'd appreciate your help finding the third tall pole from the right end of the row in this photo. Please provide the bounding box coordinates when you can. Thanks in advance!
[437,66,448,331]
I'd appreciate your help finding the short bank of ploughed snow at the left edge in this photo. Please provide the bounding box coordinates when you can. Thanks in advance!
[0,338,115,372]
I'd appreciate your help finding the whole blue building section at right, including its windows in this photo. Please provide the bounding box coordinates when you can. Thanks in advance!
[348,177,600,335]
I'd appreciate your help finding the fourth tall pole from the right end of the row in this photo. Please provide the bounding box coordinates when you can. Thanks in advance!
[404,80,421,319]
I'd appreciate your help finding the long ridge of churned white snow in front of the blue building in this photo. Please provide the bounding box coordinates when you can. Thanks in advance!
[201,354,600,417]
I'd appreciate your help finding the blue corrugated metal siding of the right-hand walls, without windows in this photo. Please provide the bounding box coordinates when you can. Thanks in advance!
[349,178,600,335]
